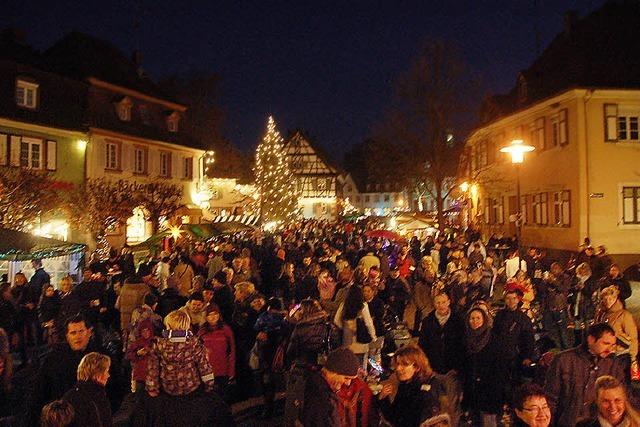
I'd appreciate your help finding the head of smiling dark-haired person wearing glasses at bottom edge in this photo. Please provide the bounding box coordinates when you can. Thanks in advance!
[512,383,551,427]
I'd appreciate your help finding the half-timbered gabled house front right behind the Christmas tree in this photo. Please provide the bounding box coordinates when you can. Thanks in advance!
[285,132,338,220]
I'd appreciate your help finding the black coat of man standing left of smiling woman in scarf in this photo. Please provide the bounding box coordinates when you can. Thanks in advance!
[418,310,464,375]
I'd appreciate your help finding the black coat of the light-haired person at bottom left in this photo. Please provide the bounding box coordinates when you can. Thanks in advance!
[62,381,113,427]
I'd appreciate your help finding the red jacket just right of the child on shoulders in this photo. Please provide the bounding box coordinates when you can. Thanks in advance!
[198,324,236,377]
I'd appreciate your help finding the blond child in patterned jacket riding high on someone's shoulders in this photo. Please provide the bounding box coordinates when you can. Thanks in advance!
[146,310,214,397]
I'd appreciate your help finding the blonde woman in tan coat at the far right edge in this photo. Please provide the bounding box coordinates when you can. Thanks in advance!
[595,285,640,381]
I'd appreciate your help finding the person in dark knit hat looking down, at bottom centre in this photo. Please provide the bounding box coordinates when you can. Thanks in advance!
[300,347,362,427]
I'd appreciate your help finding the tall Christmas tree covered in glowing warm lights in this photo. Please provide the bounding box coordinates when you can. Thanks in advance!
[254,116,299,224]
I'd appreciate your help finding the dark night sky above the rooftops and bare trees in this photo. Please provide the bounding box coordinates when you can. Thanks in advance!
[0,0,604,159]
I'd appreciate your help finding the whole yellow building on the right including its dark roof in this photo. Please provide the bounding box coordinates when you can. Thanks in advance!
[461,2,640,265]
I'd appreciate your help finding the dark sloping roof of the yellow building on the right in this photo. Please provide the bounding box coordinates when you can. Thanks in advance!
[480,0,640,124]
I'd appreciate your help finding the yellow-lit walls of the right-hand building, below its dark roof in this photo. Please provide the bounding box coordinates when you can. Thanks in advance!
[463,88,640,264]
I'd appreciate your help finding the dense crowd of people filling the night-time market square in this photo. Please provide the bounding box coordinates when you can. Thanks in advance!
[0,221,640,427]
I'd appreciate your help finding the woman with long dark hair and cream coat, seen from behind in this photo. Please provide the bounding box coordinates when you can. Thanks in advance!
[333,286,377,362]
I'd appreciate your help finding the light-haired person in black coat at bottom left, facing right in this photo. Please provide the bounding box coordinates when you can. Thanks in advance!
[62,352,113,427]
